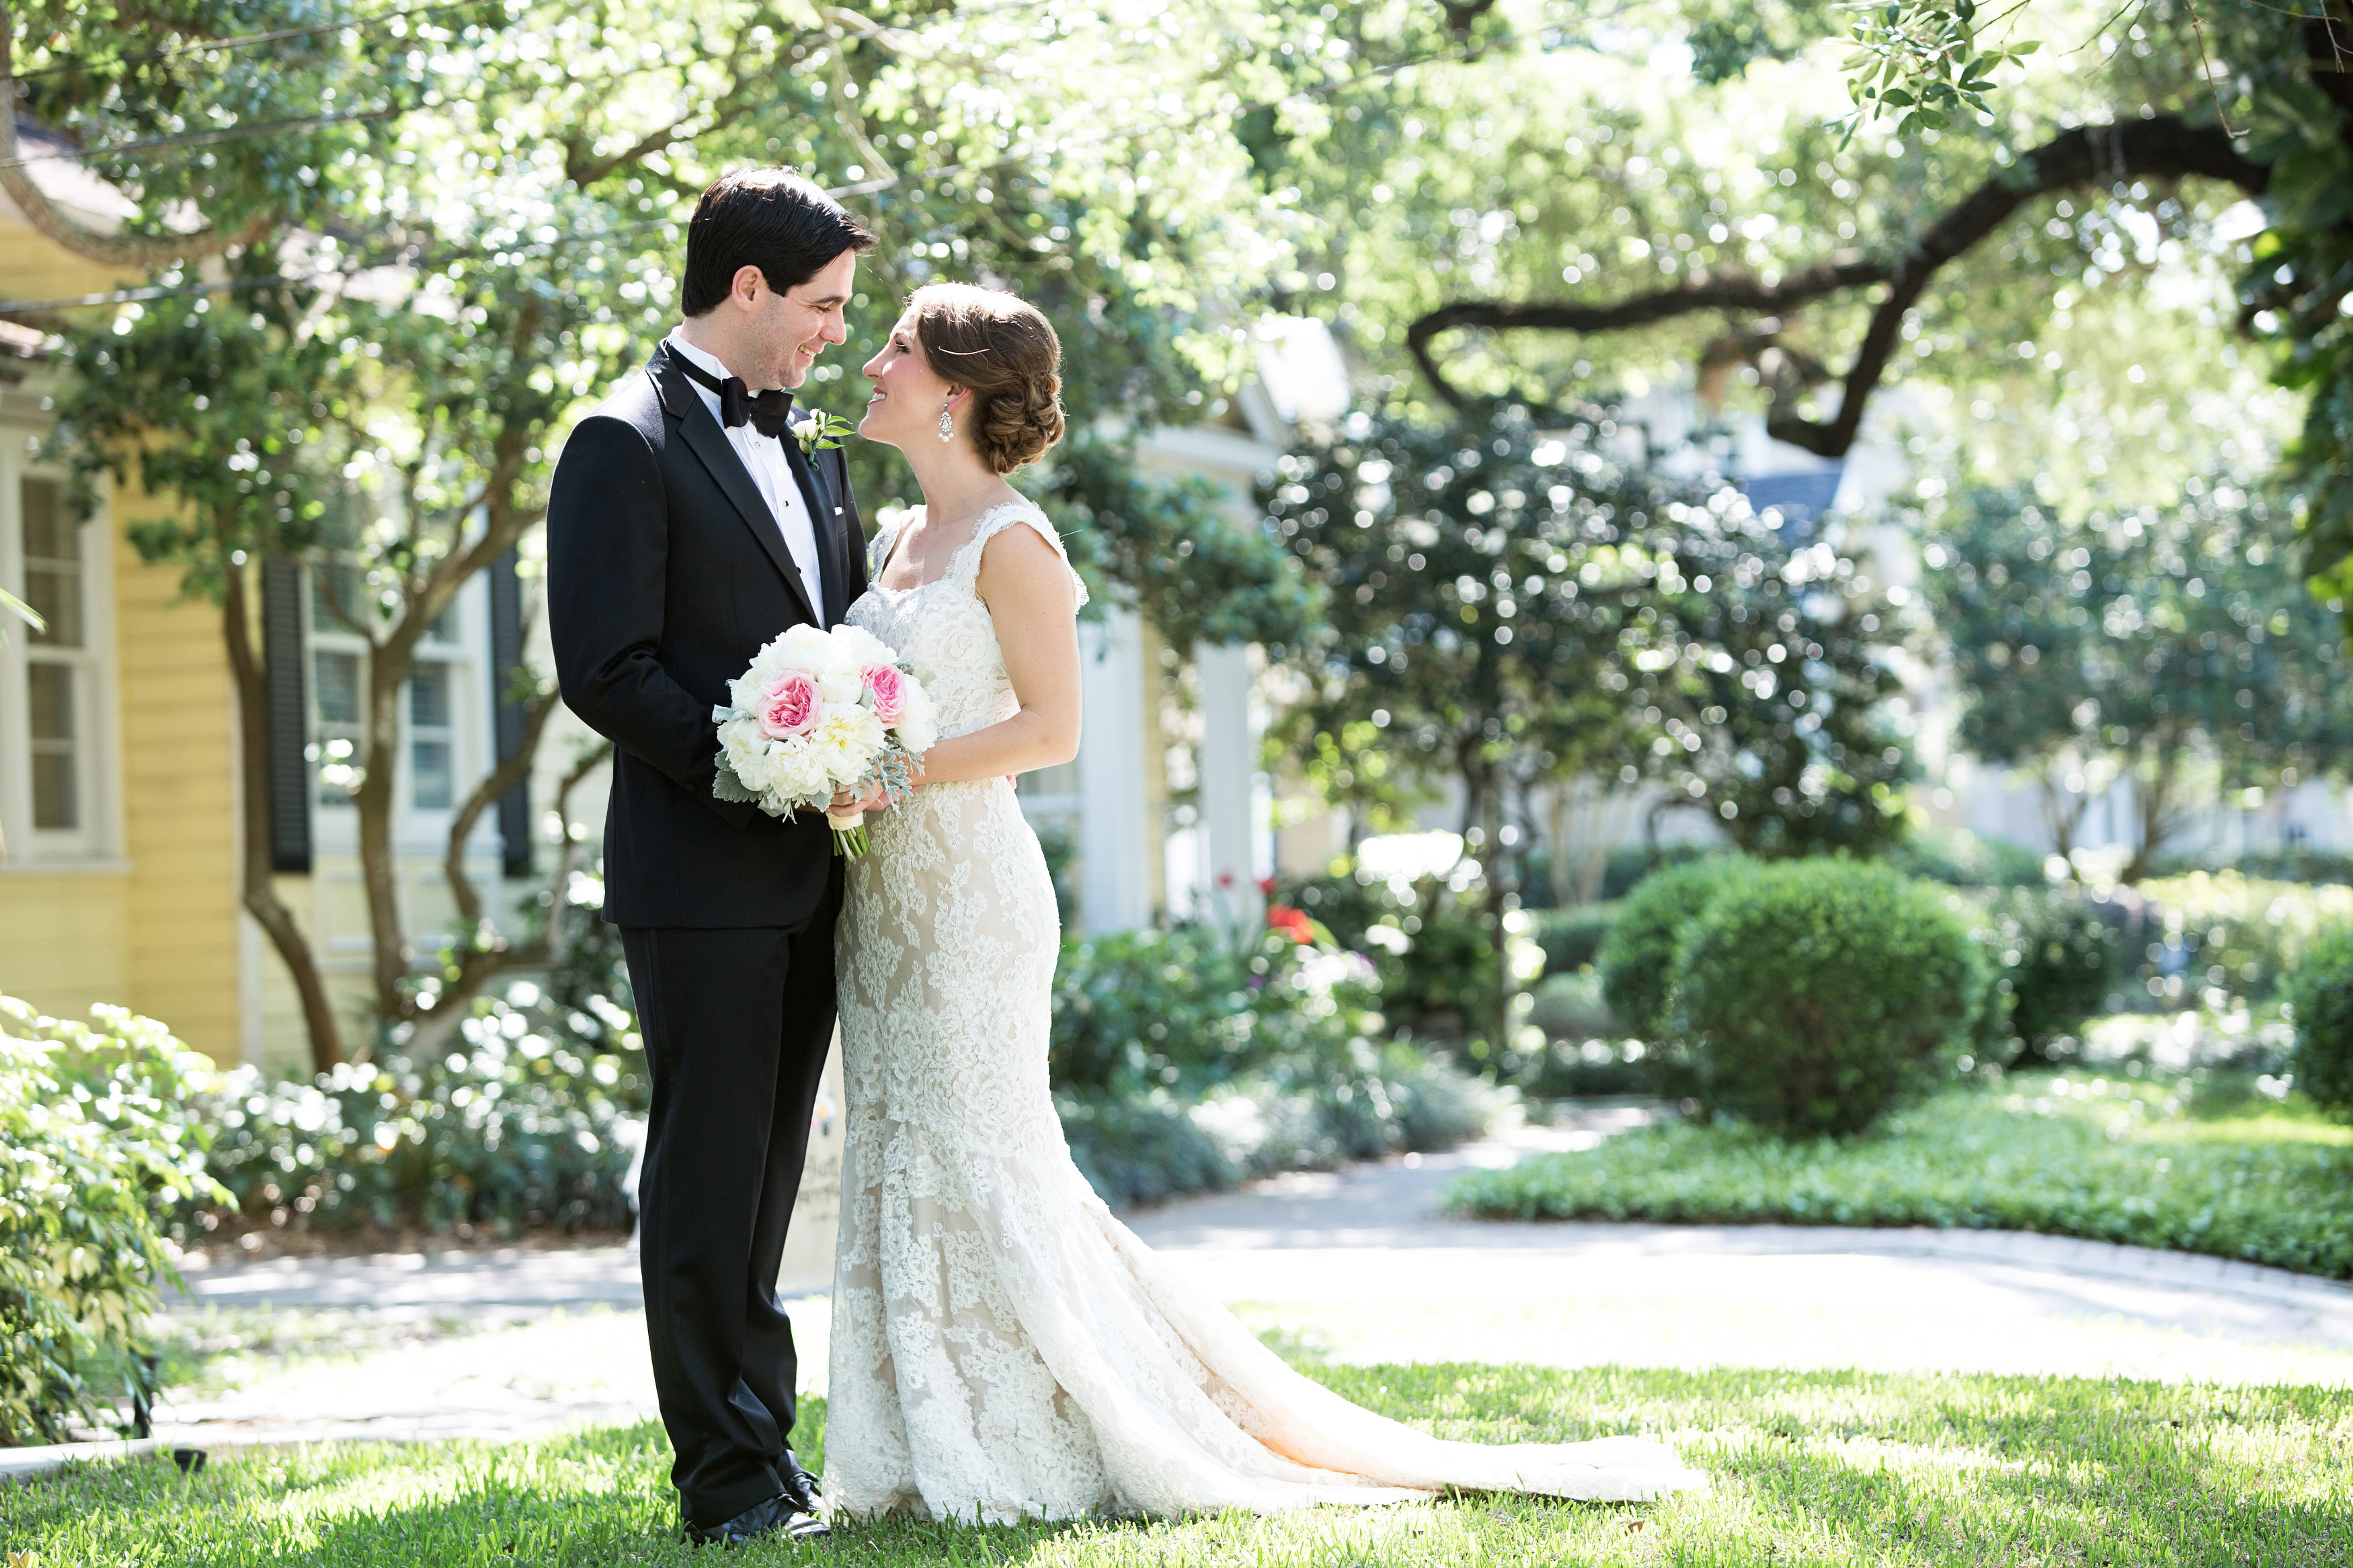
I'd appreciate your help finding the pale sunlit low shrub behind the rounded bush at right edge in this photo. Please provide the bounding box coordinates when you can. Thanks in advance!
[2137,872,2353,1001]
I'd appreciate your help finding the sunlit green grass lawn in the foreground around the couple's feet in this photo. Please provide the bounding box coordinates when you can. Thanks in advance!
[0,1366,2353,1568]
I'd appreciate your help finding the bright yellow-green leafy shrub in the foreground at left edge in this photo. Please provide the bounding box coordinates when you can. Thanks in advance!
[0,997,214,1444]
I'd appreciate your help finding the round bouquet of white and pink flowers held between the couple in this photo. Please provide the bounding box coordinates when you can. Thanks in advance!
[711,625,939,856]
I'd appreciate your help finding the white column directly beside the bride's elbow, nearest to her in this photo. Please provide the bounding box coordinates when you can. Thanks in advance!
[1078,609,1153,936]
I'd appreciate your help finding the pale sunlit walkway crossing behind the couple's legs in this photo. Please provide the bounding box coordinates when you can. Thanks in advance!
[142,1112,2353,1444]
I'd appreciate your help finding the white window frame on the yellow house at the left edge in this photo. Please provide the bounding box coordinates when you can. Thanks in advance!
[0,454,122,874]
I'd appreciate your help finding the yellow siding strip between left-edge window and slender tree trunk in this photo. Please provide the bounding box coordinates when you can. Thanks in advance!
[113,485,243,1063]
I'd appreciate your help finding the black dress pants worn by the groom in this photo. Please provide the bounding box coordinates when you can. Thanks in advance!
[621,884,842,1528]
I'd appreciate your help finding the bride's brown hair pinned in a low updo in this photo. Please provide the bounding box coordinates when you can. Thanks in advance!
[906,282,1062,472]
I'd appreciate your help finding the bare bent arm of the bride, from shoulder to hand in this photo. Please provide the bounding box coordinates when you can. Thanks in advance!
[916,526,1078,783]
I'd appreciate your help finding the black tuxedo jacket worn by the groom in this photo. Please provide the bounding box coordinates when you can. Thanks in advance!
[549,345,866,926]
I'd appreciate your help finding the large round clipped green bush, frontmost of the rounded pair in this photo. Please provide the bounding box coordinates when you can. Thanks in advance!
[1666,860,1989,1133]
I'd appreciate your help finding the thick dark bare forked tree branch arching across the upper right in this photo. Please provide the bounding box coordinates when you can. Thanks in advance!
[1405,115,2271,444]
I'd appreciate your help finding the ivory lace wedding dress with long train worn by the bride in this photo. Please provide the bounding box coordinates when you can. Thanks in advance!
[824,503,1704,1521]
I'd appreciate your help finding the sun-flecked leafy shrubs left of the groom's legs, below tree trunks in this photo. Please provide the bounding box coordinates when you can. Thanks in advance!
[198,985,647,1237]
